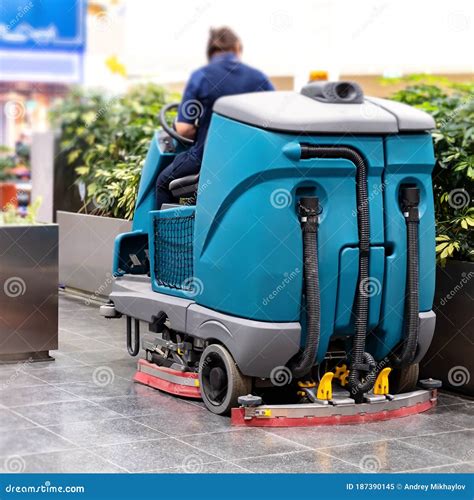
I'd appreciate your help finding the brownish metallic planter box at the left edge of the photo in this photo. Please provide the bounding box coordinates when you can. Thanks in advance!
[0,224,58,362]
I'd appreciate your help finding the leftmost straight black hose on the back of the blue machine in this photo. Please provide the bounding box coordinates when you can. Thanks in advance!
[291,197,321,378]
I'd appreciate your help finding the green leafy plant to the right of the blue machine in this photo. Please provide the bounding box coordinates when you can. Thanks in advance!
[392,82,474,265]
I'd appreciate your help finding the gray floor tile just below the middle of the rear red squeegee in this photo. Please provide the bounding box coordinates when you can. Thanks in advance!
[268,425,380,448]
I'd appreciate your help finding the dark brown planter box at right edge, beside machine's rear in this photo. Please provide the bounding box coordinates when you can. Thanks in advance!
[421,261,474,396]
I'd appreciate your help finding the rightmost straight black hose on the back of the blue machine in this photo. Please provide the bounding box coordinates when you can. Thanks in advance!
[394,186,420,365]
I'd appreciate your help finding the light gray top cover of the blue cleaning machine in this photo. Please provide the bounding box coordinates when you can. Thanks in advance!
[214,91,435,134]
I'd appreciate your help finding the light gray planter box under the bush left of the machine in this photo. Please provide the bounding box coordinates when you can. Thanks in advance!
[57,211,132,298]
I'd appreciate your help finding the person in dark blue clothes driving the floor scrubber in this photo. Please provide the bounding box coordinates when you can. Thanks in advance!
[156,27,274,210]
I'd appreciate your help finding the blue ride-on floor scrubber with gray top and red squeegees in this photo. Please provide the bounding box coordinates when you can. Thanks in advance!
[101,82,439,426]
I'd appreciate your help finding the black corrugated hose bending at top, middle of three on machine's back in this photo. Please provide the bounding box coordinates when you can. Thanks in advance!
[301,144,377,402]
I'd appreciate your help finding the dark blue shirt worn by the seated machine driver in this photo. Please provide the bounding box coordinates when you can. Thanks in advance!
[178,52,275,159]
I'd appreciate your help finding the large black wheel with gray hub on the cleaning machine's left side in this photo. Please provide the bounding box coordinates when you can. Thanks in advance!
[199,344,252,415]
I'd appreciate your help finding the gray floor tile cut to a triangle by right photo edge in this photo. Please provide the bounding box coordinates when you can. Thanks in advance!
[402,430,474,462]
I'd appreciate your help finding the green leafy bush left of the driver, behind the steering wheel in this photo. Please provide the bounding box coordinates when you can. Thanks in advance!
[52,84,176,219]
